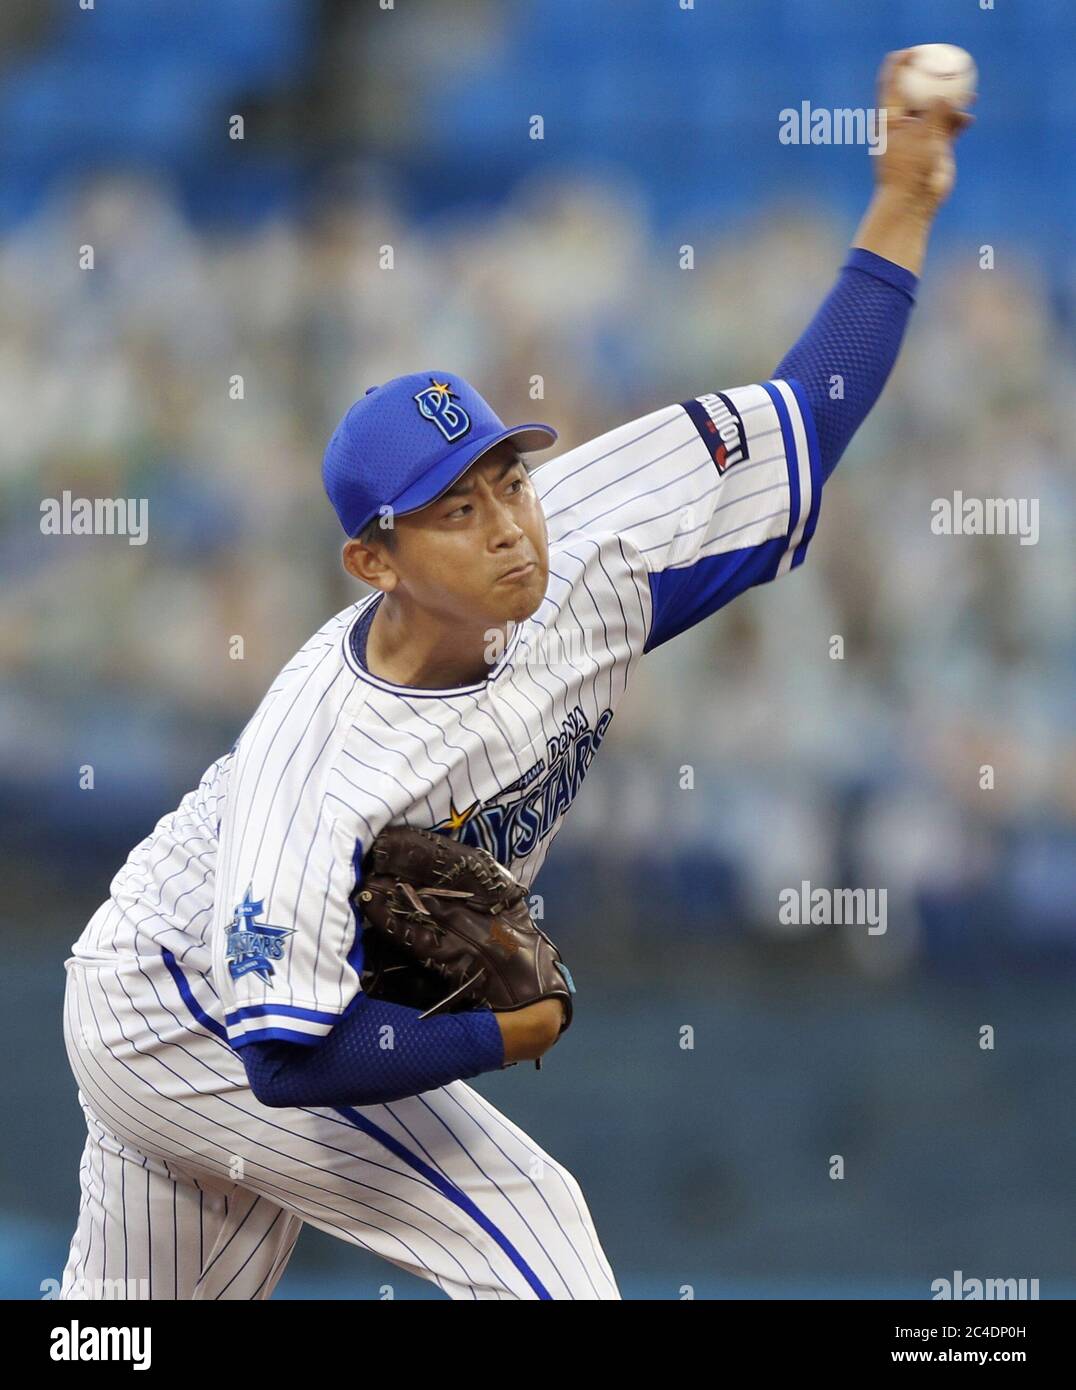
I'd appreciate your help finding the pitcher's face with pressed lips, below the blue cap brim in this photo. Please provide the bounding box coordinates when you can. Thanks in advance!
[378,441,549,626]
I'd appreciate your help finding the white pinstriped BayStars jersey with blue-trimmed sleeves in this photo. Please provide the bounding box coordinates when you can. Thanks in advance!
[75,382,822,1045]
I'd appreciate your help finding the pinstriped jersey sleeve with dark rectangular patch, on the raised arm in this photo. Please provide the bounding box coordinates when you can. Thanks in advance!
[535,381,823,651]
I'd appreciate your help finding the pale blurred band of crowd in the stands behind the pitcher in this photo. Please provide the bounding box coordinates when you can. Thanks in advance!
[0,162,1076,945]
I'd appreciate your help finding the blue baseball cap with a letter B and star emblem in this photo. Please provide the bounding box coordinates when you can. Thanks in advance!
[321,371,556,537]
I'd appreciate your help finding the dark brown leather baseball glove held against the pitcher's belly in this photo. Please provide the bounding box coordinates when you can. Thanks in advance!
[352,826,576,1066]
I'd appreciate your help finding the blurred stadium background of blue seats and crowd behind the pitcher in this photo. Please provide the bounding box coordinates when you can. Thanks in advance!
[0,0,1076,1298]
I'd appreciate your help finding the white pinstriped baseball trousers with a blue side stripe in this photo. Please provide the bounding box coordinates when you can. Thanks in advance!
[61,960,617,1300]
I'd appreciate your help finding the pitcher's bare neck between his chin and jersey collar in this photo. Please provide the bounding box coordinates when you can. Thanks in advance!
[366,594,507,689]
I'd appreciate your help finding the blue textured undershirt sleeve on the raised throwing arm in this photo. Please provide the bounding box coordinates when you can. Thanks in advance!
[773,247,919,478]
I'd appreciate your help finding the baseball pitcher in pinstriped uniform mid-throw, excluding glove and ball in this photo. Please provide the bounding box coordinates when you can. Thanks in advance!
[61,56,966,1300]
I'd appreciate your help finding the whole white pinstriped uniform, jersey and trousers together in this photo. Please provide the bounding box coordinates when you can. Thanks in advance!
[65,382,819,1300]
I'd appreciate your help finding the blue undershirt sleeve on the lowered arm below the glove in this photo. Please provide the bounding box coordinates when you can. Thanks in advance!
[239,994,505,1106]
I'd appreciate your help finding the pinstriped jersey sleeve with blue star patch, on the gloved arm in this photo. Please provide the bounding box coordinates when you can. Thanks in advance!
[214,719,375,1048]
